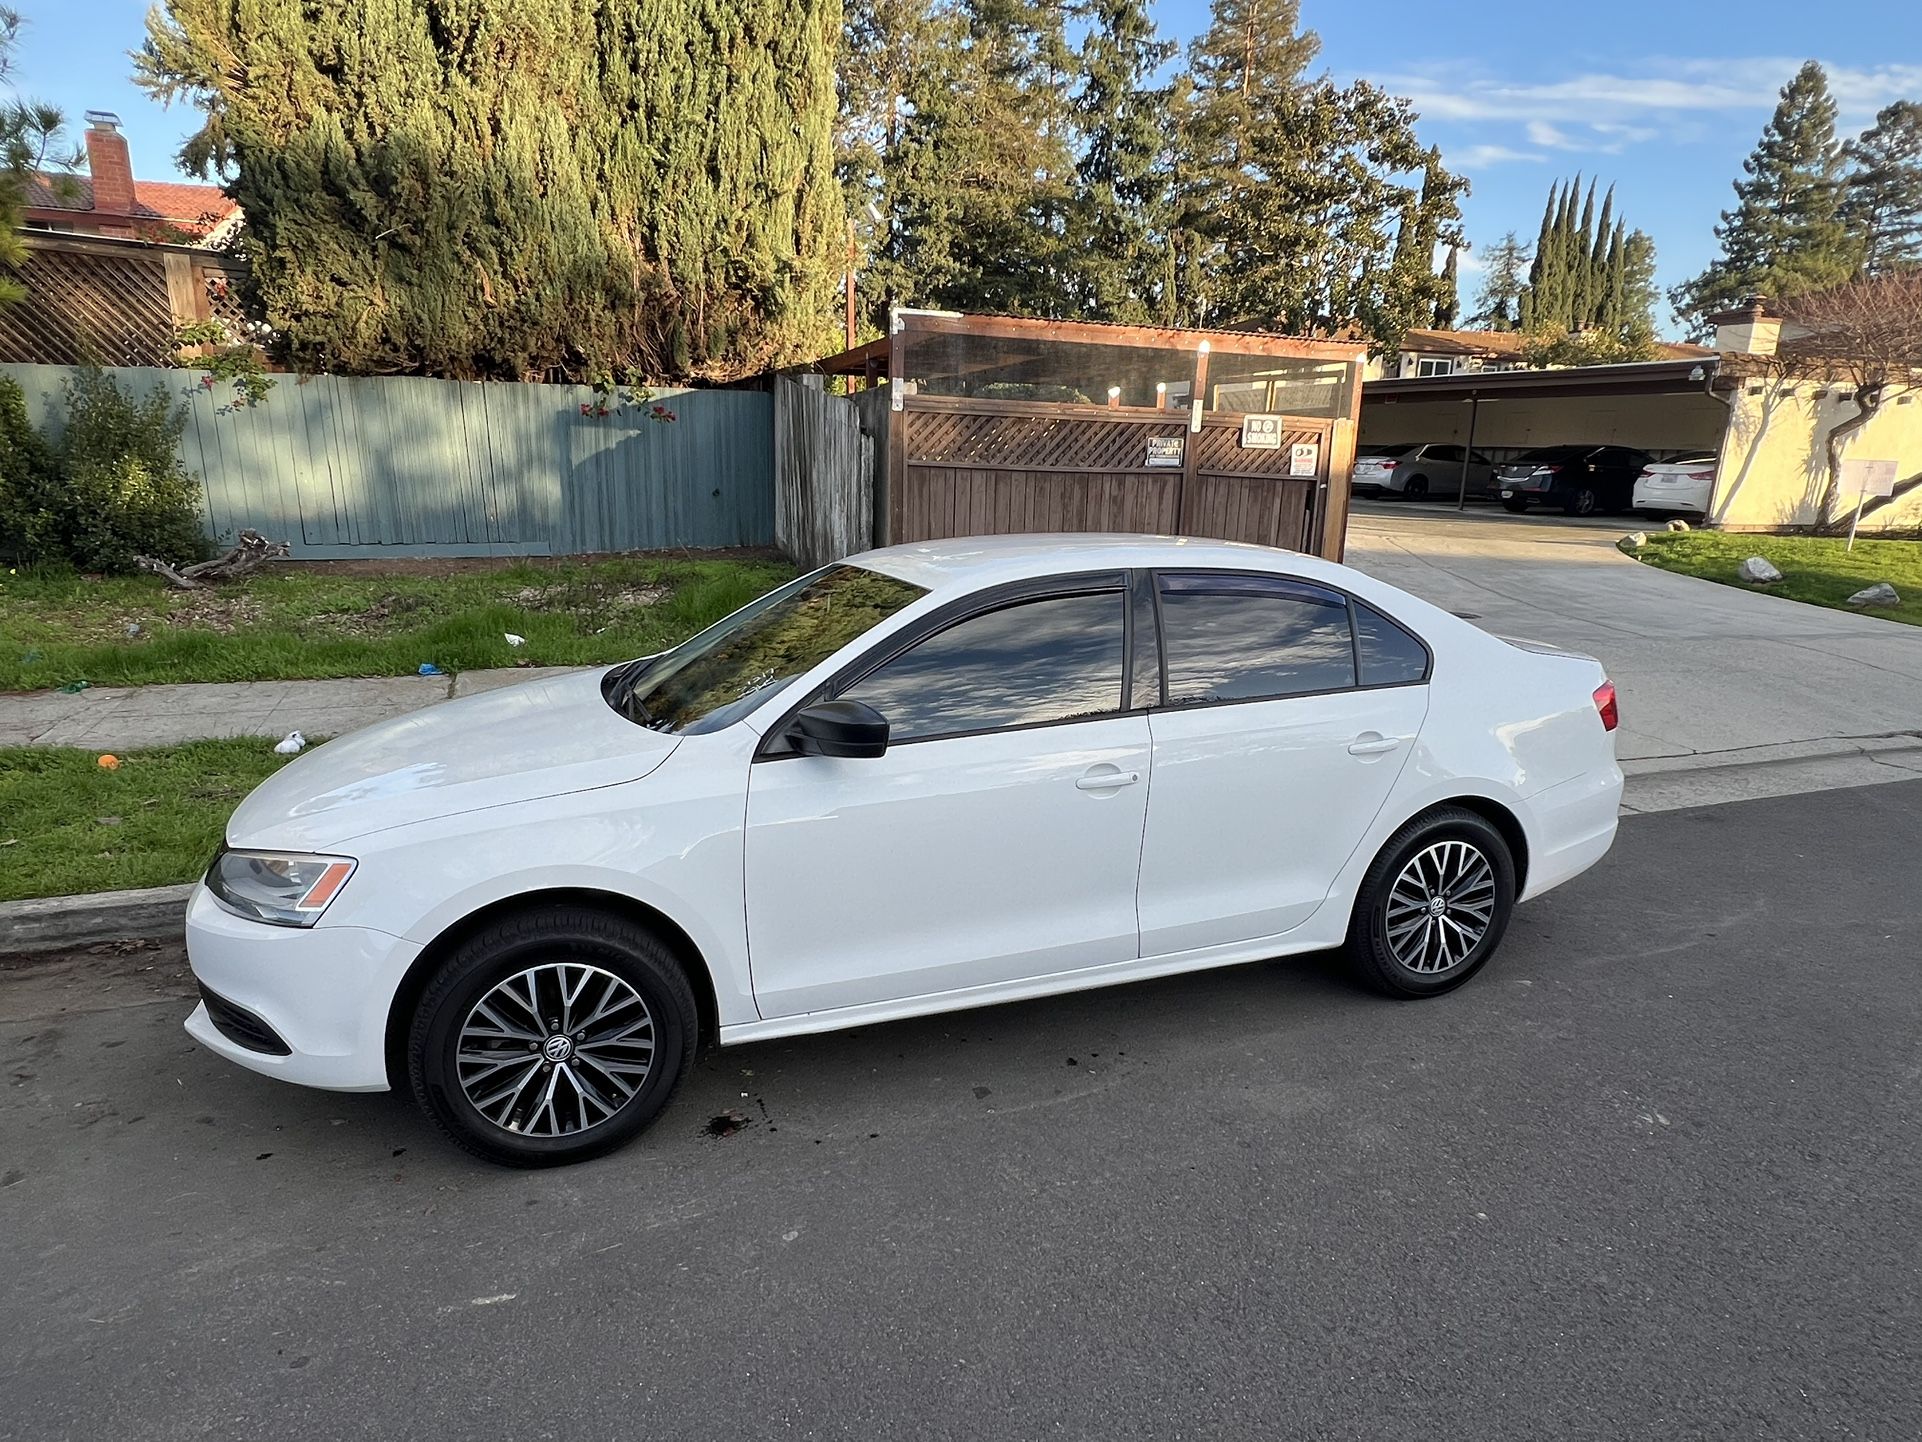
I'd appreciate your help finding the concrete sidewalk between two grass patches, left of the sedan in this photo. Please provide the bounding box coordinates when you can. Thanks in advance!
[0,665,577,752]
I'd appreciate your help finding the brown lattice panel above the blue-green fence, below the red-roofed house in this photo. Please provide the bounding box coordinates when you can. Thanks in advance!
[0,246,173,365]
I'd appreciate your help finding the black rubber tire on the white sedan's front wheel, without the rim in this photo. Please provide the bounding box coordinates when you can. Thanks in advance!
[407,906,700,1167]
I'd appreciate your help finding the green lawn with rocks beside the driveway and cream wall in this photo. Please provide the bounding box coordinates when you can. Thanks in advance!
[1630,531,1922,625]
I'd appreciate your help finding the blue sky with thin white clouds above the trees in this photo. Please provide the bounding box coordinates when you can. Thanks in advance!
[3,0,1922,332]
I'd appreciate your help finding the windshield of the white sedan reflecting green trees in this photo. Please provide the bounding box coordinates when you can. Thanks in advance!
[602,565,926,734]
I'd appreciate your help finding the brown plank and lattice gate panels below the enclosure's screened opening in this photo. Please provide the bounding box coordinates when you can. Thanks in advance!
[888,396,1334,550]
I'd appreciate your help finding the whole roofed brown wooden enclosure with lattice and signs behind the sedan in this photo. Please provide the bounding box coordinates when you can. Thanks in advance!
[815,310,1363,559]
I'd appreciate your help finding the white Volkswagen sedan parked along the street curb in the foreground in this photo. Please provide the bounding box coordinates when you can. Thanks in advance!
[186,536,1622,1165]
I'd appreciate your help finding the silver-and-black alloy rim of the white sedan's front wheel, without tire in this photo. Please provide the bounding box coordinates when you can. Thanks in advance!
[456,961,655,1138]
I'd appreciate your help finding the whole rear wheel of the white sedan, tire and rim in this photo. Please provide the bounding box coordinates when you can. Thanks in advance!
[1347,806,1515,1000]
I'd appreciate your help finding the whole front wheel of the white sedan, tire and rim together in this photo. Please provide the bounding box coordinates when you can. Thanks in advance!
[407,906,700,1167]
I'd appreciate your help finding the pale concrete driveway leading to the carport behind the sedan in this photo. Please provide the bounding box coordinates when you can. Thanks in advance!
[1347,506,1922,784]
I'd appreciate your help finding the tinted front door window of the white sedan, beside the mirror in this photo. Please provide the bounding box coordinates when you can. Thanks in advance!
[842,590,1126,740]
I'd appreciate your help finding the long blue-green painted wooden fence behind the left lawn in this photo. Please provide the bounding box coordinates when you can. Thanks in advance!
[0,365,775,559]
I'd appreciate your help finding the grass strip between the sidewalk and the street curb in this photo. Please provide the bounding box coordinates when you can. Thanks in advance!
[0,736,311,902]
